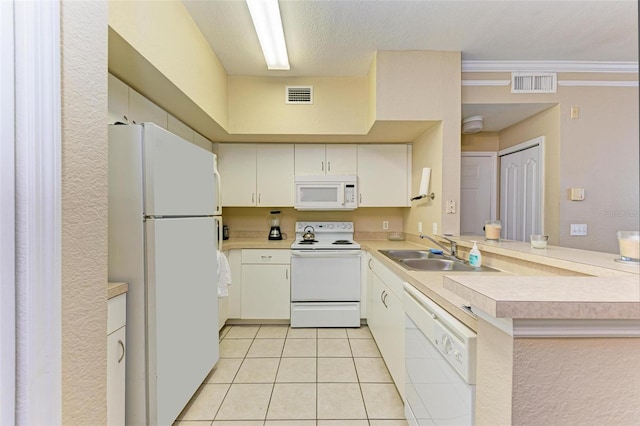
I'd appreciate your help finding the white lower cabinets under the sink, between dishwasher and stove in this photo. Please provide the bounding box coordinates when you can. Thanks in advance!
[367,258,405,396]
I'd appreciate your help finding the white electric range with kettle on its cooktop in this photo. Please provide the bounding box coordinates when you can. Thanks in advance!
[291,222,361,327]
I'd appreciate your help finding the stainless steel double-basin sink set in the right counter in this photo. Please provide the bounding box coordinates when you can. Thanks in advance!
[380,250,499,272]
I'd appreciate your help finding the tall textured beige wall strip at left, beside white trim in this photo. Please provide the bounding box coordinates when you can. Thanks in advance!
[61,1,107,425]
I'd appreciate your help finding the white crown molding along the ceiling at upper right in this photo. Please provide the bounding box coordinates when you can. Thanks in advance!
[462,61,638,73]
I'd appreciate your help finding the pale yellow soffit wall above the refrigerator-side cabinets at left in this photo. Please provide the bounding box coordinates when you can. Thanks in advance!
[109,0,228,127]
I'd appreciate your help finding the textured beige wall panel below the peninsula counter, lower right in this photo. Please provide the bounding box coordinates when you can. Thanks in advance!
[512,338,640,426]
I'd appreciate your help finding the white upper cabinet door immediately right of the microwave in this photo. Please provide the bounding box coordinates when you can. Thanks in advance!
[358,144,411,207]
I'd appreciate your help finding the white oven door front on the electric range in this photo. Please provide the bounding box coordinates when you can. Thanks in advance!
[291,254,360,302]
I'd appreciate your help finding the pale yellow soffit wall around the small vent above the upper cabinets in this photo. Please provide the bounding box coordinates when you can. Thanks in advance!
[228,76,369,135]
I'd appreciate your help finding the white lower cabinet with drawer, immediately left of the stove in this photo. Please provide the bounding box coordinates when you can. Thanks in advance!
[240,249,291,319]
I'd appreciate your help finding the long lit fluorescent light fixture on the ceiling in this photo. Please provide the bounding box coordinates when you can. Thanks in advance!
[247,0,290,70]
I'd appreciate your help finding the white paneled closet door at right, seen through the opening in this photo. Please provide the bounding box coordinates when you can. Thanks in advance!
[500,144,543,241]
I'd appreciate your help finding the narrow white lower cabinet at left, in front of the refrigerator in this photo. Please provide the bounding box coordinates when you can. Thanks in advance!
[107,294,127,425]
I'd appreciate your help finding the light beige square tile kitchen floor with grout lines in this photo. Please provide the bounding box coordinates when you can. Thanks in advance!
[174,325,407,426]
